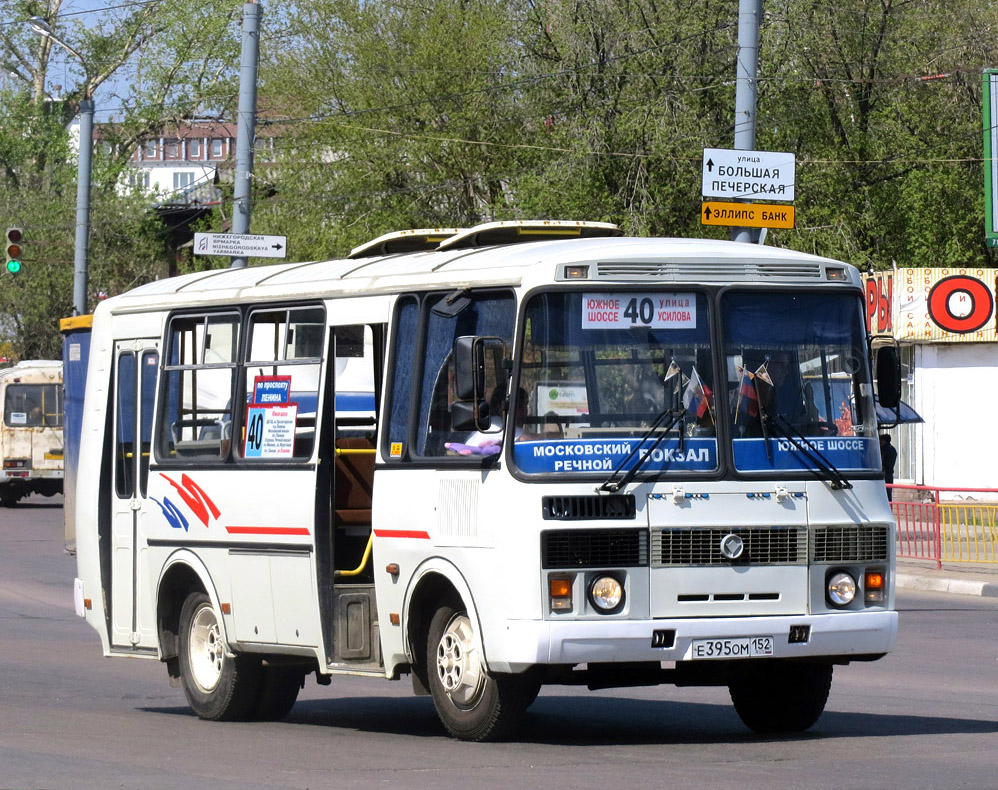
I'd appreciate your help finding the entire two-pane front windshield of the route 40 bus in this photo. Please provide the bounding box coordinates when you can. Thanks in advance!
[513,288,878,475]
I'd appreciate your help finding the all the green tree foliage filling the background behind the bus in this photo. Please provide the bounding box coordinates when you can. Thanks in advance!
[0,0,998,356]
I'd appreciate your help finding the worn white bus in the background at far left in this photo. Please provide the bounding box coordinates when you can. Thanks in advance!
[0,360,63,507]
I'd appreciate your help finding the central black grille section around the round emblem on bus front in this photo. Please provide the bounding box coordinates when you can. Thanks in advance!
[651,527,807,568]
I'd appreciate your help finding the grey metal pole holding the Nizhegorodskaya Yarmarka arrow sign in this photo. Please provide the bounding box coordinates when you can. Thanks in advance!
[229,2,262,269]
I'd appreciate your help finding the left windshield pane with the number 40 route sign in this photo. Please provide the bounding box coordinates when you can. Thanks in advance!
[513,289,718,474]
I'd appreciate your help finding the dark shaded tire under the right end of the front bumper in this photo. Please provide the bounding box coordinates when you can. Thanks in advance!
[728,661,833,735]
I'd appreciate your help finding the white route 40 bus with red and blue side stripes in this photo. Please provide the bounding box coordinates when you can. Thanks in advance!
[76,222,898,740]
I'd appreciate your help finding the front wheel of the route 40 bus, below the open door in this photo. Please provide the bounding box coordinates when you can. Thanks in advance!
[426,605,539,741]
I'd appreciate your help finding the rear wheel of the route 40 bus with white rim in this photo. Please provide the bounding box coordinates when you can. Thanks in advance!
[180,591,261,721]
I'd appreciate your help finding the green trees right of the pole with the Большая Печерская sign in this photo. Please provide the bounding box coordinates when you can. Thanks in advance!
[759,0,998,267]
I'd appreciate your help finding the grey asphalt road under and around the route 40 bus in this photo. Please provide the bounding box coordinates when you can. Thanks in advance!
[0,499,998,790]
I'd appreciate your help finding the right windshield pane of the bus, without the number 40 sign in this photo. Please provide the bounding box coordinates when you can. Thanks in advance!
[721,291,877,472]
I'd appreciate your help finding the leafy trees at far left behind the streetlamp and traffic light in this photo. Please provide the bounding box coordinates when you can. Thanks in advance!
[0,0,241,357]
